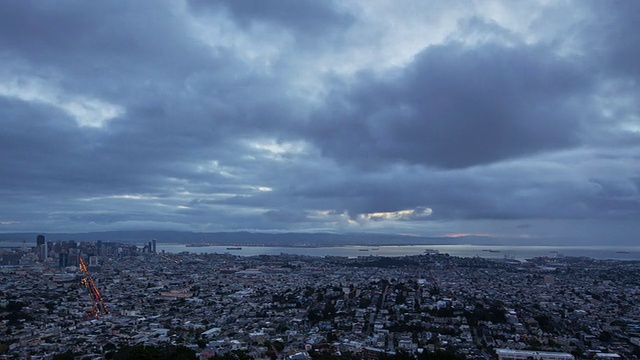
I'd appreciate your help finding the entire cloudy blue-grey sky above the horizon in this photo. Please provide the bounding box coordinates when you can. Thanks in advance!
[0,0,640,245]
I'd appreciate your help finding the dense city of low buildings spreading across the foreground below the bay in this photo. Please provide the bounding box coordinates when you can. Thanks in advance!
[0,239,640,359]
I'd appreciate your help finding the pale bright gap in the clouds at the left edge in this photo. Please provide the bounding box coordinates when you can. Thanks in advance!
[0,79,124,129]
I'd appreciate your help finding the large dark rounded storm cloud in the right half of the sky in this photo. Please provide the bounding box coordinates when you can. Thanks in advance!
[310,39,590,168]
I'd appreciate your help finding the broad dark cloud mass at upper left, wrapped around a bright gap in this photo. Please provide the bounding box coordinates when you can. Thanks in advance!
[0,2,298,192]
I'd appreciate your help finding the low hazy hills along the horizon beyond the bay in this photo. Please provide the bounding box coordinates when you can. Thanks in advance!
[0,230,512,246]
